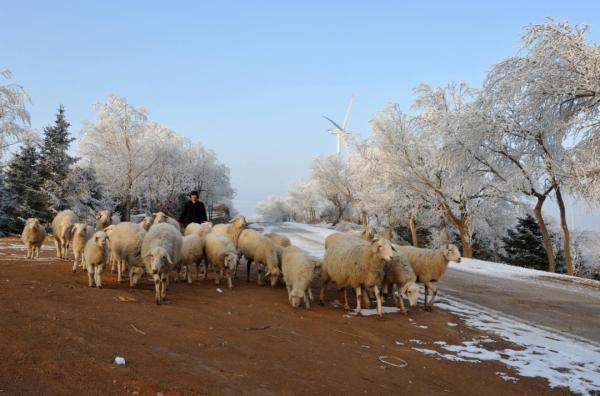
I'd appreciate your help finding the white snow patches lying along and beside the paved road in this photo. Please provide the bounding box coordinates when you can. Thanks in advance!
[264,223,600,394]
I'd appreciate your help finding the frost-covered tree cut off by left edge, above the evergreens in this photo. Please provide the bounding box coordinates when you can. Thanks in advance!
[0,69,31,159]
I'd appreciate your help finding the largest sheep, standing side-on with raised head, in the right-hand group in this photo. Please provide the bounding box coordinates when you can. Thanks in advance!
[319,238,393,316]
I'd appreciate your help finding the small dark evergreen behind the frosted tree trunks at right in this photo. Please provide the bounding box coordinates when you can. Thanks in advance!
[502,214,548,271]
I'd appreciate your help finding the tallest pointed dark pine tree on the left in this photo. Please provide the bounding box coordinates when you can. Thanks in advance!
[40,105,75,212]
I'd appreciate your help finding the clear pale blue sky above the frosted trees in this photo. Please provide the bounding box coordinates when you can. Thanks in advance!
[0,0,600,229]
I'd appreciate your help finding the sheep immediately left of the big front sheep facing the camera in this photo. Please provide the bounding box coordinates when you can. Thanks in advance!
[106,222,146,287]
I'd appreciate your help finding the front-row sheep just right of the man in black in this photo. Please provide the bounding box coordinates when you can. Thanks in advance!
[204,232,238,289]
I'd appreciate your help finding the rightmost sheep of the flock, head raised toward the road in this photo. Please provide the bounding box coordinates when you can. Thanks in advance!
[397,244,460,311]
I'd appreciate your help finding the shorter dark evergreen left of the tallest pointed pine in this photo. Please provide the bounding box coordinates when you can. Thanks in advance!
[6,142,51,226]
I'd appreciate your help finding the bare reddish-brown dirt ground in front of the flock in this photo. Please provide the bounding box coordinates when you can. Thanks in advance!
[0,238,568,395]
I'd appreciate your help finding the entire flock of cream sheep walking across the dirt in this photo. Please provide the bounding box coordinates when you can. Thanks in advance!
[21,210,461,316]
